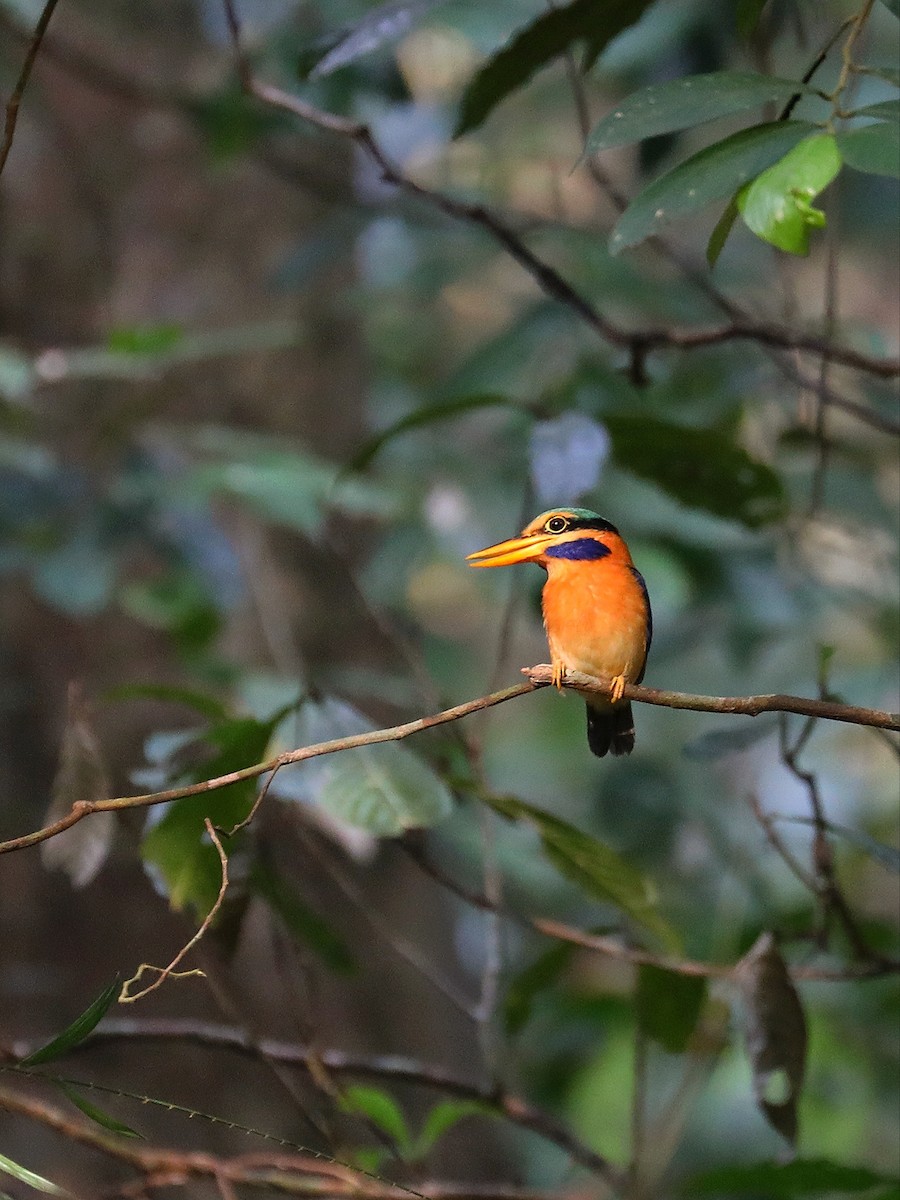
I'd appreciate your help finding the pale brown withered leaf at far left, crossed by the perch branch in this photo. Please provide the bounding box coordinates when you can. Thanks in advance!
[41,684,115,888]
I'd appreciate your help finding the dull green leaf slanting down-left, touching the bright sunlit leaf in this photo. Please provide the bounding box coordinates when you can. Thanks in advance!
[610,121,817,254]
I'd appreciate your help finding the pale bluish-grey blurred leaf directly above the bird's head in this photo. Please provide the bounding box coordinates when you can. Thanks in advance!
[529,412,610,505]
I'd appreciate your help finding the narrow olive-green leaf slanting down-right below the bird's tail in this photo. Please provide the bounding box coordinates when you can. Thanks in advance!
[487,796,680,953]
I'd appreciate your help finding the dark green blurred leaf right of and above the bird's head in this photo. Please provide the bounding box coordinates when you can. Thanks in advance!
[606,414,786,529]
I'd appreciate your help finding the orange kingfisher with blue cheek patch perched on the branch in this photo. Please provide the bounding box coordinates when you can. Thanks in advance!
[467,509,653,758]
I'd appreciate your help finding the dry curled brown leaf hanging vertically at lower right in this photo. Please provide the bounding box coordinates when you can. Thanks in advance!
[734,934,806,1145]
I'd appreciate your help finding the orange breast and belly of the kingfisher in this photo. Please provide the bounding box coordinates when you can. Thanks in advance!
[542,546,649,683]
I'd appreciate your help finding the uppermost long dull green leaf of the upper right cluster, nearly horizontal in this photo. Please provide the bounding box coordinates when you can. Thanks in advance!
[584,71,811,155]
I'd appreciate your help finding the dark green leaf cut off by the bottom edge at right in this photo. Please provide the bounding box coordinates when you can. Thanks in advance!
[683,1158,890,1200]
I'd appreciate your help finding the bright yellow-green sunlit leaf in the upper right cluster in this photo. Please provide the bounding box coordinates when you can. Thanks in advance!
[738,133,841,254]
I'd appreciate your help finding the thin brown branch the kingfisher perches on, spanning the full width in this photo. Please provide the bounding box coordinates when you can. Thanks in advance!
[0,662,900,854]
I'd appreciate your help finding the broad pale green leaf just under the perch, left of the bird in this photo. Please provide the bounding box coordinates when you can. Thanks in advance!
[317,742,452,838]
